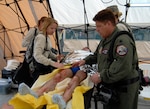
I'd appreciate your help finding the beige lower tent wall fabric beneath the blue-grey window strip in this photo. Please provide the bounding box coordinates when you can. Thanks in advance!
[64,40,150,61]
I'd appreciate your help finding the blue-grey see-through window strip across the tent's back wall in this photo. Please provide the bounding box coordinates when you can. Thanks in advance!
[58,27,150,41]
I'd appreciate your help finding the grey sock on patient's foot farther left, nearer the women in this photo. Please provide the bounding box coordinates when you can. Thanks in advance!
[18,83,38,98]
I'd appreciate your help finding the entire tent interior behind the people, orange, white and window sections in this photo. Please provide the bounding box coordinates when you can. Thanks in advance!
[0,0,150,70]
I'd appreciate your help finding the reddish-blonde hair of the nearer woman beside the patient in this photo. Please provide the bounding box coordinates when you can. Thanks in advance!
[41,17,58,36]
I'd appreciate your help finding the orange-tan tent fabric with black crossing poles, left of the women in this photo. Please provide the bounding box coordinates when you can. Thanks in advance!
[0,0,54,62]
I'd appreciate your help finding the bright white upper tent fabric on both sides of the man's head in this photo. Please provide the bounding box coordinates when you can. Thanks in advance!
[49,0,150,26]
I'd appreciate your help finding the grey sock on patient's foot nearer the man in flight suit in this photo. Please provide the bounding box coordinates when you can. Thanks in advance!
[52,94,66,109]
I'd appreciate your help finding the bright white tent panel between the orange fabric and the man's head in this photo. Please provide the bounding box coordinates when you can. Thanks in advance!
[49,0,105,26]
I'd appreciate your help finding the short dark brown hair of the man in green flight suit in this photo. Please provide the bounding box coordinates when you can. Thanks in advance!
[93,9,116,25]
